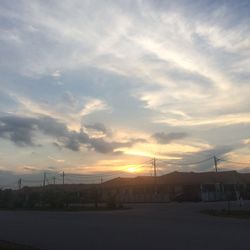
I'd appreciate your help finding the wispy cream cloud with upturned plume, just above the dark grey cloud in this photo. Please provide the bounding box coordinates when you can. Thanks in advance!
[9,91,110,131]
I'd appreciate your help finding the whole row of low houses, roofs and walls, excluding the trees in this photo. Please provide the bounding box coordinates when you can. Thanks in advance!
[15,171,250,203]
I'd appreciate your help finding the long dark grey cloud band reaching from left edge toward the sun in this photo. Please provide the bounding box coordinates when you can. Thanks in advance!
[0,116,142,154]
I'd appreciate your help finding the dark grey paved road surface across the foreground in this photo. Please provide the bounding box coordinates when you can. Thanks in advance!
[0,203,250,250]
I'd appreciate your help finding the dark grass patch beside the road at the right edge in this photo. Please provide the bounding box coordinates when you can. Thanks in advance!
[201,209,250,219]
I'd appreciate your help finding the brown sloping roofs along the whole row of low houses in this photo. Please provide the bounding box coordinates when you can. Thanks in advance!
[19,171,250,191]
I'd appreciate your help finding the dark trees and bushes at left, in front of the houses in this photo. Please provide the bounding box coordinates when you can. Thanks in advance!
[0,187,122,210]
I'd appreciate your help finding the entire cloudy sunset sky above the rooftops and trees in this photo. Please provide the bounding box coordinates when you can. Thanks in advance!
[0,0,250,188]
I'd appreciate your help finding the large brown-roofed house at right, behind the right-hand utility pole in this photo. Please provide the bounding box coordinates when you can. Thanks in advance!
[158,171,246,201]
